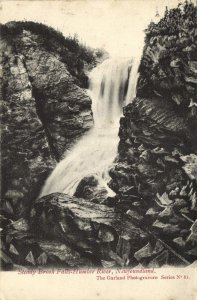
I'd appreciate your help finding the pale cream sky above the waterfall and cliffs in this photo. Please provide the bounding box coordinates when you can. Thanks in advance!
[0,0,179,57]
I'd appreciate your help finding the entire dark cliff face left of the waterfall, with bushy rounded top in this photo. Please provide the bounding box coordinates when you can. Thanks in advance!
[1,22,93,217]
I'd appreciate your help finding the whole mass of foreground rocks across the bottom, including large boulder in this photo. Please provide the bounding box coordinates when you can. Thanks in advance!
[1,193,192,269]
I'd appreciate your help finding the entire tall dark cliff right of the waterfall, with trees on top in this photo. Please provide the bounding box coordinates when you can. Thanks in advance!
[109,4,197,262]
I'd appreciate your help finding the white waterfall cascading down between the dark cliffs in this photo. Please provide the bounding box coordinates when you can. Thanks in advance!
[40,59,139,196]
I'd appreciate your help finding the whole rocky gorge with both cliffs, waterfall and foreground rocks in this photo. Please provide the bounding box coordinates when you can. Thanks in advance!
[1,1,197,270]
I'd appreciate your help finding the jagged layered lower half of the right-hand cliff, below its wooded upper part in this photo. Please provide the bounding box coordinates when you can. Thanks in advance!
[110,98,197,251]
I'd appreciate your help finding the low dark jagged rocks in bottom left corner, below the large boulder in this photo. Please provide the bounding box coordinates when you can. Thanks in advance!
[2,216,93,270]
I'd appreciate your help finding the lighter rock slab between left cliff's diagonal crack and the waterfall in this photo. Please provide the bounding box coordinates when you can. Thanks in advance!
[13,31,93,160]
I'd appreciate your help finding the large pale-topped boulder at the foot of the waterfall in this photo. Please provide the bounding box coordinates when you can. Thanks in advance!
[28,194,147,265]
